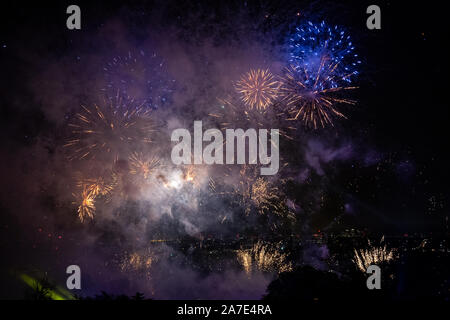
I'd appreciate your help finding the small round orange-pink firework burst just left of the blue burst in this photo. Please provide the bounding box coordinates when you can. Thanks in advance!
[235,69,279,110]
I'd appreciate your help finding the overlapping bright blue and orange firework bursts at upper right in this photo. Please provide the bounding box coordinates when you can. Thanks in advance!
[280,22,361,129]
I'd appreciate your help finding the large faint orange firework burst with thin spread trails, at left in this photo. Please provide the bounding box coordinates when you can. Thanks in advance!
[64,97,154,160]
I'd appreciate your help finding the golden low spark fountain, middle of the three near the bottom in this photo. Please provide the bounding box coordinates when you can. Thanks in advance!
[237,241,292,274]
